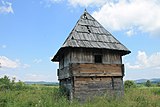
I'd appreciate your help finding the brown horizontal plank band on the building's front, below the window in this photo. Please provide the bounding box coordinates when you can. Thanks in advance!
[70,64,123,76]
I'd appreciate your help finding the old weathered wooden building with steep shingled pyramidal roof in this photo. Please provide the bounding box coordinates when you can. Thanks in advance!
[52,10,130,101]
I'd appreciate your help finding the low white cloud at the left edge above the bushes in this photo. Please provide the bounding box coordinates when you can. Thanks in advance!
[0,56,30,69]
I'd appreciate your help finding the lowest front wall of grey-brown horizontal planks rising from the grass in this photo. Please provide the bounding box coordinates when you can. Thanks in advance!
[74,77,123,101]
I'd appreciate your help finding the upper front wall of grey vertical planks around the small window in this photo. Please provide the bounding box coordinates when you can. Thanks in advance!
[70,49,122,64]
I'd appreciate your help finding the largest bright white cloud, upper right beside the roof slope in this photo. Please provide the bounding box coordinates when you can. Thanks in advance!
[92,0,160,35]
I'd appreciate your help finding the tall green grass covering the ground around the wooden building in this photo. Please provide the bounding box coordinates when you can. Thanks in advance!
[0,85,160,107]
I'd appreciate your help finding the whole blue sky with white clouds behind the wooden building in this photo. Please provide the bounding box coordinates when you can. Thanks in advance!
[0,0,160,82]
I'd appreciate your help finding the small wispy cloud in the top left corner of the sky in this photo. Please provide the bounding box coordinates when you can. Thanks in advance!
[0,0,14,14]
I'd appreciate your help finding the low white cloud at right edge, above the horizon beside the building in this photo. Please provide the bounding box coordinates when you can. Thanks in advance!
[126,51,160,70]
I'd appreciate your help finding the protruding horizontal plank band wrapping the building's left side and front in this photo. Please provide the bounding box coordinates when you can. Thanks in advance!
[58,64,124,79]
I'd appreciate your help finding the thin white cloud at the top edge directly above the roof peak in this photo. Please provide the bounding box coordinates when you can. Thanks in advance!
[68,0,108,7]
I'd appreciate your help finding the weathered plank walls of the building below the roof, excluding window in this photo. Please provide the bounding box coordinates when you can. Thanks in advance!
[58,49,124,100]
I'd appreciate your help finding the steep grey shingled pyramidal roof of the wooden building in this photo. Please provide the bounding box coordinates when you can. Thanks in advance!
[52,10,130,61]
